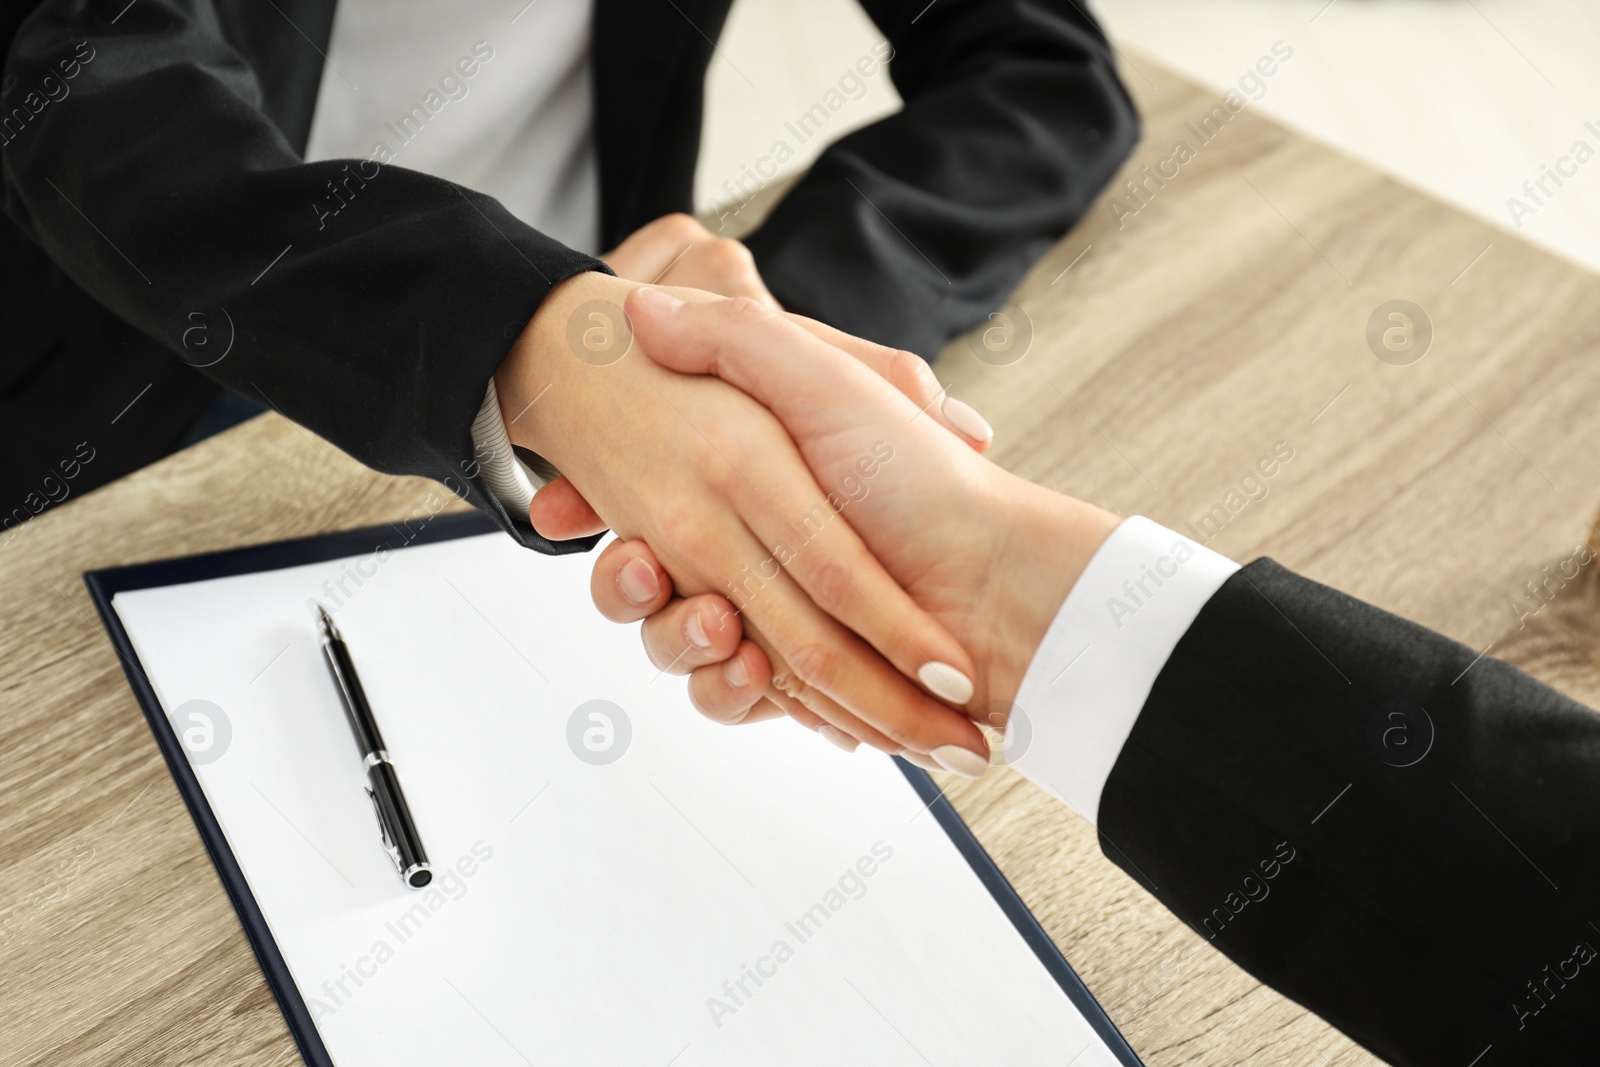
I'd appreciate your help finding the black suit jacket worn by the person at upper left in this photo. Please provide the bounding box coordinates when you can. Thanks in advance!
[0,0,1136,552]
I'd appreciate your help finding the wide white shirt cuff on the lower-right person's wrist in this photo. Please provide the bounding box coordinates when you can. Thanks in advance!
[1006,515,1238,824]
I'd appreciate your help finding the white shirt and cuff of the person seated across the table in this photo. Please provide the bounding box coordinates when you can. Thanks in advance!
[306,0,600,515]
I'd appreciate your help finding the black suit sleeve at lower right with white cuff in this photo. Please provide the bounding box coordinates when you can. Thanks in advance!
[1099,560,1600,1067]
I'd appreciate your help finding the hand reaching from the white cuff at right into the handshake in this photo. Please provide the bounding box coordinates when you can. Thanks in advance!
[594,291,1118,764]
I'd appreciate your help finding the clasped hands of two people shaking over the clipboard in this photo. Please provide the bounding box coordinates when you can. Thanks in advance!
[496,221,1118,777]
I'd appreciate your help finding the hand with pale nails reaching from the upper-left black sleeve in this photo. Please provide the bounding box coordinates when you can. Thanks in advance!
[494,274,987,764]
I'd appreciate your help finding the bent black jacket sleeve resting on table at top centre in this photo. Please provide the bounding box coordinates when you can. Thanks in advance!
[747,0,1139,358]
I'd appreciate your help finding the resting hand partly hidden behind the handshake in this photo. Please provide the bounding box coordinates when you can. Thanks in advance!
[602,214,779,307]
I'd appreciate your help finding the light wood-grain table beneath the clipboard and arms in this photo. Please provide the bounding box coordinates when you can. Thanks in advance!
[0,58,1600,1067]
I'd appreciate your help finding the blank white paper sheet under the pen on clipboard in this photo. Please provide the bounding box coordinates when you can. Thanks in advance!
[114,534,1115,1067]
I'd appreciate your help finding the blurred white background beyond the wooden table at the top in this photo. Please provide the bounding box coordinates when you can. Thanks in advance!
[696,0,1600,270]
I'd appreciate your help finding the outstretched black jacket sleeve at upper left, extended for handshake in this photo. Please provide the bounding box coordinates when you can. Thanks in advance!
[0,0,605,552]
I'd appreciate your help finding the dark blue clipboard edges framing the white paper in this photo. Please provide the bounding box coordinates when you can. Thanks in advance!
[83,512,1144,1067]
